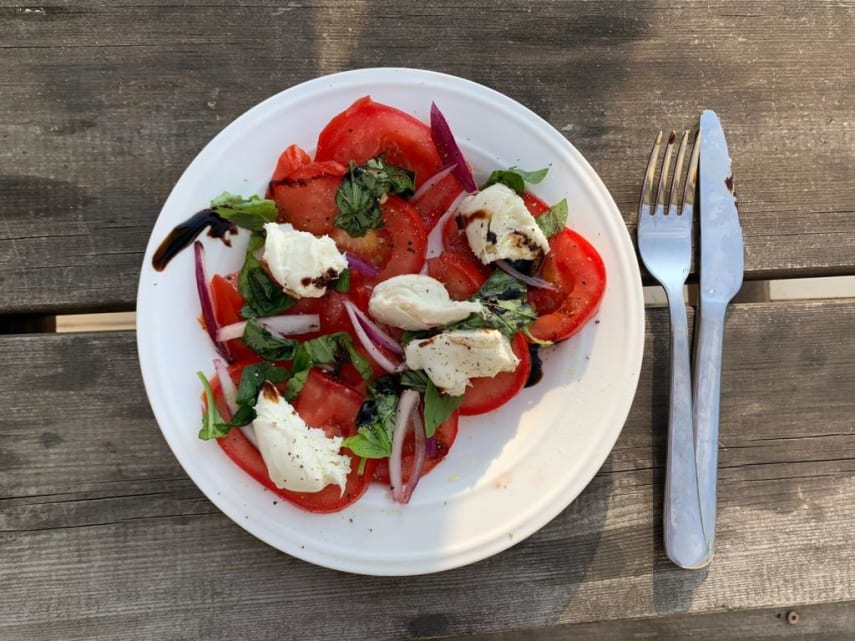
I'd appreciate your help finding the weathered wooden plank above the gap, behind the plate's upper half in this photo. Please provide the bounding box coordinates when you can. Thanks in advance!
[0,0,855,313]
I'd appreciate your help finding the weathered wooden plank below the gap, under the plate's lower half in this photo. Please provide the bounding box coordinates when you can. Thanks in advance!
[0,301,855,641]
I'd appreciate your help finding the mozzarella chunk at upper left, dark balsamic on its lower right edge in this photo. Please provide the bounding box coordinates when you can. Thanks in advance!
[262,223,347,298]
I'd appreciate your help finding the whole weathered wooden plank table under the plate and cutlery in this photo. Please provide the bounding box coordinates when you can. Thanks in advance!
[0,0,855,640]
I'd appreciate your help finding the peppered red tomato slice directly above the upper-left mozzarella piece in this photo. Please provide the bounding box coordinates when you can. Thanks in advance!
[270,158,347,236]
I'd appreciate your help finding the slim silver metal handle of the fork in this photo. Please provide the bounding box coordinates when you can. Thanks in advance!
[664,287,706,569]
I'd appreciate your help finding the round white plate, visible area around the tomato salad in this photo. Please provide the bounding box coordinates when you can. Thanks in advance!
[137,69,644,575]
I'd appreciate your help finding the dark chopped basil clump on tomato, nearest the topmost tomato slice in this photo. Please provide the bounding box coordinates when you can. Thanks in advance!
[333,156,415,238]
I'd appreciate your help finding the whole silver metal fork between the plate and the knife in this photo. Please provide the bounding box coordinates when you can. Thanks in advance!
[638,131,706,568]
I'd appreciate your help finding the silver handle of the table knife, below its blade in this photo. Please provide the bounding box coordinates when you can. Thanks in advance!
[693,300,727,564]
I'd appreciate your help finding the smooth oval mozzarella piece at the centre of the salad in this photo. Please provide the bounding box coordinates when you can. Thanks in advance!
[368,274,483,330]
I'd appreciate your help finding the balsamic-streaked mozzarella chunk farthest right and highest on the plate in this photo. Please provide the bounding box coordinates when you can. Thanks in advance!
[457,183,549,265]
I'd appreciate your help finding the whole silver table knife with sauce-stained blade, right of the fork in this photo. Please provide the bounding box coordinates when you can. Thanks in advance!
[692,111,744,567]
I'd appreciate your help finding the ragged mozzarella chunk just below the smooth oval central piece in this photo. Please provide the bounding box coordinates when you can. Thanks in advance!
[404,329,520,396]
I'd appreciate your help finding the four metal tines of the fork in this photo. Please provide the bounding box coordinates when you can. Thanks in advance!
[638,131,701,215]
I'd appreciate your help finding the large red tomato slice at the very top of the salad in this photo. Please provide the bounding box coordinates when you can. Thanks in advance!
[315,96,442,187]
